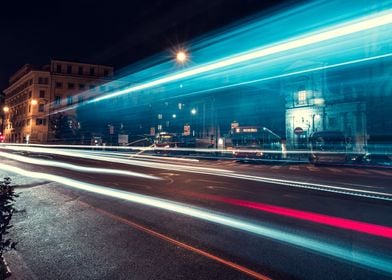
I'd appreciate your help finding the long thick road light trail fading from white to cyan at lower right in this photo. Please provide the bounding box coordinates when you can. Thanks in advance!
[0,164,392,274]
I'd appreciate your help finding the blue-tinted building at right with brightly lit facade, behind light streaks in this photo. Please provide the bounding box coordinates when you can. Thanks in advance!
[281,56,392,152]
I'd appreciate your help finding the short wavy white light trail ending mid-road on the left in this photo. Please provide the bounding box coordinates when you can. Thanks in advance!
[0,152,160,180]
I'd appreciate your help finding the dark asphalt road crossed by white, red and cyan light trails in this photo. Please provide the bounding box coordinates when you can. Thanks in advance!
[0,150,392,279]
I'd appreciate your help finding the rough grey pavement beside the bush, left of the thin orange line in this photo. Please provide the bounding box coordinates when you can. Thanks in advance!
[5,178,248,280]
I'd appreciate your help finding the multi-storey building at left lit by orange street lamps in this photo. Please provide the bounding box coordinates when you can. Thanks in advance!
[4,60,113,143]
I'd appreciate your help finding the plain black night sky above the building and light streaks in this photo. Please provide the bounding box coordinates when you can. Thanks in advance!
[0,0,287,91]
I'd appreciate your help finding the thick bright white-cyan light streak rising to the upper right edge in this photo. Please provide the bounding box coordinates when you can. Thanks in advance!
[89,10,392,102]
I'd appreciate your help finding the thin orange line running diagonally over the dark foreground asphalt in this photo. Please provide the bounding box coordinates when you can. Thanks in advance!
[79,201,272,280]
